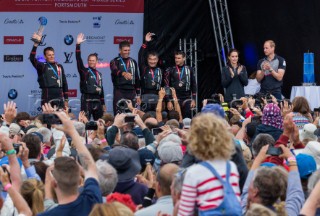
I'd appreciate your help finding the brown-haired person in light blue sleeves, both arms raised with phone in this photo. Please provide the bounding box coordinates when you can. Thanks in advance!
[241,145,304,215]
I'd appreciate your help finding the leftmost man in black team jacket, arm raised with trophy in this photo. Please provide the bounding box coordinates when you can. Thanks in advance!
[30,33,68,108]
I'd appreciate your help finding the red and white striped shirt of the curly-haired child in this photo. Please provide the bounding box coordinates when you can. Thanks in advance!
[178,160,240,216]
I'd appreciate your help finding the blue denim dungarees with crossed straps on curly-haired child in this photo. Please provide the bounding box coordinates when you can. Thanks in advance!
[198,161,242,216]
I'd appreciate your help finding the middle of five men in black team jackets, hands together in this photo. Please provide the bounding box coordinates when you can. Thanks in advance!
[110,41,141,114]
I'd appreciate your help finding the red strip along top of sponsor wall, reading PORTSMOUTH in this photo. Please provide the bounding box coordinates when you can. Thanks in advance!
[0,0,144,13]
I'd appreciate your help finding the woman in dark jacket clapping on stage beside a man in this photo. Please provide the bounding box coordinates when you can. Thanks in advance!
[221,49,248,102]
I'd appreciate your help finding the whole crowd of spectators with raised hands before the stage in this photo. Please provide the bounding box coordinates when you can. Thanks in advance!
[0,88,320,216]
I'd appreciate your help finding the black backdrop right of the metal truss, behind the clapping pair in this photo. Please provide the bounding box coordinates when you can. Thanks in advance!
[228,0,320,97]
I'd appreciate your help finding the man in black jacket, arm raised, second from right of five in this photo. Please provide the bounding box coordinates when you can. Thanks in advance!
[138,32,163,111]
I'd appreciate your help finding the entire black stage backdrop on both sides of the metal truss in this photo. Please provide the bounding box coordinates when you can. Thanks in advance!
[144,0,320,99]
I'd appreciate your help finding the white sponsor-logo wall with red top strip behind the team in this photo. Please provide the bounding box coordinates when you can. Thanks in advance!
[0,0,144,116]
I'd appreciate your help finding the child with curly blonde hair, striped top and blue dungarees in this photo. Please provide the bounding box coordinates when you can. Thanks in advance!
[178,113,241,215]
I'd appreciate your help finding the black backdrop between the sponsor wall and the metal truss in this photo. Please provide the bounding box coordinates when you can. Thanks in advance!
[144,0,222,101]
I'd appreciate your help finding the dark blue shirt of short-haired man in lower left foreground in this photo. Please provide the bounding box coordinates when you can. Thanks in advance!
[38,178,102,216]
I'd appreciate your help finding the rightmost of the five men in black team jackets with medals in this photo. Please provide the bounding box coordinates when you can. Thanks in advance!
[164,51,197,118]
